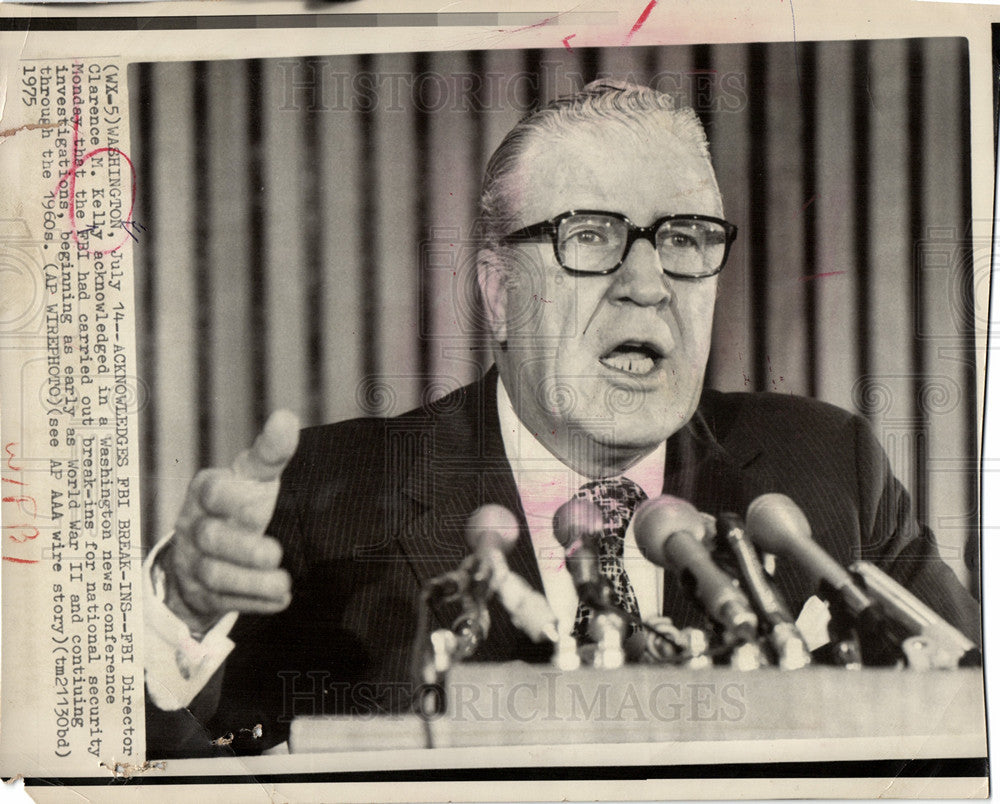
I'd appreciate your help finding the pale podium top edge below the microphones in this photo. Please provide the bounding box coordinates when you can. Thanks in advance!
[289,662,986,756]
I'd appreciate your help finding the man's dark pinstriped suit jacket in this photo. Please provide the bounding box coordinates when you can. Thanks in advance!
[147,371,980,756]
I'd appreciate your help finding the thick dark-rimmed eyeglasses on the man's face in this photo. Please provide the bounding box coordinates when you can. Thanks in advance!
[504,210,736,279]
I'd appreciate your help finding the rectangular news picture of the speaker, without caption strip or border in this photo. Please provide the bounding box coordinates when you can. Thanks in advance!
[128,38,985,775]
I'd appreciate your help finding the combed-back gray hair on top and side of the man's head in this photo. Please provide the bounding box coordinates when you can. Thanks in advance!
[479,78,718,251]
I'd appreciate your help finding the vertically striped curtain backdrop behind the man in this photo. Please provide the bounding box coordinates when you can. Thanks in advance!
[129,39,978,585]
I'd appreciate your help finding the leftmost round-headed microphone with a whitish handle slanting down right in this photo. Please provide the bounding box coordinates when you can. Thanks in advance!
[465,504,559,642]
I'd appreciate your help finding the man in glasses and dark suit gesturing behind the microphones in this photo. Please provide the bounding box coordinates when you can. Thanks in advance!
[145,81,979,756]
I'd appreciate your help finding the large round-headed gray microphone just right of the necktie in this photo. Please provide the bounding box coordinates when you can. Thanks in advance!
[632,495,757,643]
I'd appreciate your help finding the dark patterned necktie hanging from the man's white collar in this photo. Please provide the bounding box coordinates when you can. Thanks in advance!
[573,477,646,642]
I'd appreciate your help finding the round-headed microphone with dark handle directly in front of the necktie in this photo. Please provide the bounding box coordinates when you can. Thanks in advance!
[552,497,614,611]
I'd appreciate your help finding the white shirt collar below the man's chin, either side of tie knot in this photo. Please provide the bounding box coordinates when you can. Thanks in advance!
[497,377,667,516]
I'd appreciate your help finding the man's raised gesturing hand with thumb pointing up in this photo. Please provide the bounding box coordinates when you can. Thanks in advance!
[162,410,299,632]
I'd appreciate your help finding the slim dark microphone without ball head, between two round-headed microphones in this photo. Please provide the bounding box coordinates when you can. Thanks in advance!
[716,513,809,670]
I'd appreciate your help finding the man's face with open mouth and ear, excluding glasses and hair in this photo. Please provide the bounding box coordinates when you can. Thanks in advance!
[484,113,722,464]
